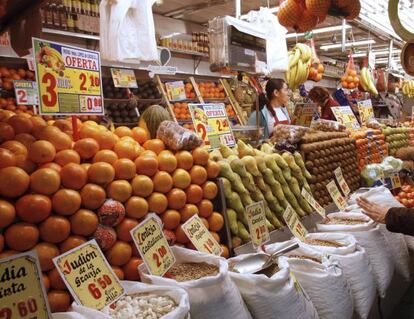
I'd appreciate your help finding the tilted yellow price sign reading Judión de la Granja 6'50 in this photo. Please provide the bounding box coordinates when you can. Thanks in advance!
[53,240,125,310]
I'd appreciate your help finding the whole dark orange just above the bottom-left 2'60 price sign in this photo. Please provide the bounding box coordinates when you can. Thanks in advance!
[4,222,39,251]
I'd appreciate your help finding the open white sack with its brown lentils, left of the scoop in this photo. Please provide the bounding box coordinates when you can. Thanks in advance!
[138,247,251,319]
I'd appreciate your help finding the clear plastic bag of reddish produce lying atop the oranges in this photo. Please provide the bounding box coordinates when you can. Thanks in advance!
[157,121,203,151]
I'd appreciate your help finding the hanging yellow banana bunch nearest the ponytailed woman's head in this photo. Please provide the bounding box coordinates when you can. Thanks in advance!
[286,43,312,90]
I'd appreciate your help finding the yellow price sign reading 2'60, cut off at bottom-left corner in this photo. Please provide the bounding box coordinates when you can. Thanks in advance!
[0,251,52,319]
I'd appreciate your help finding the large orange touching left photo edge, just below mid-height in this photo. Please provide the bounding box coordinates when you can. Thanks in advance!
[0,166,30,197]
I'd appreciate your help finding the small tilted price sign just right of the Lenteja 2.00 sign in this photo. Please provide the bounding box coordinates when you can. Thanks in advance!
[181,215,223,256]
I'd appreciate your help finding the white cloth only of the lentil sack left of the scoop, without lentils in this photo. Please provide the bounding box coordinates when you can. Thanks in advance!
[138,247,251,319]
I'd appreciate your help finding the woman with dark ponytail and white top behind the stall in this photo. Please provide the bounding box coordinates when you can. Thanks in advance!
[248,79,290,139]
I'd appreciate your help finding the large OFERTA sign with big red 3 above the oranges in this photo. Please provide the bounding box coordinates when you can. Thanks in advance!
[33,38,104,115]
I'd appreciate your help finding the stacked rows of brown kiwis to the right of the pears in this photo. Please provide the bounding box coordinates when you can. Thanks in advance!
[301,132,359,205]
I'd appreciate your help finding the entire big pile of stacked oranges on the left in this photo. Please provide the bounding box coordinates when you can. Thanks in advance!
[0,111,228,312]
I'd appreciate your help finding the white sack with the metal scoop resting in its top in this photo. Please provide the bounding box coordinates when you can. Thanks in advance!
[228,254,318,319]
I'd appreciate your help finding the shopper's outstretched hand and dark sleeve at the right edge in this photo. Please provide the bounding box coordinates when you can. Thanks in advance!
[357,197,414,236]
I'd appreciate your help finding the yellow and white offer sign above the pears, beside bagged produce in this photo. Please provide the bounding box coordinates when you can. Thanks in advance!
[188,103,236,149]
